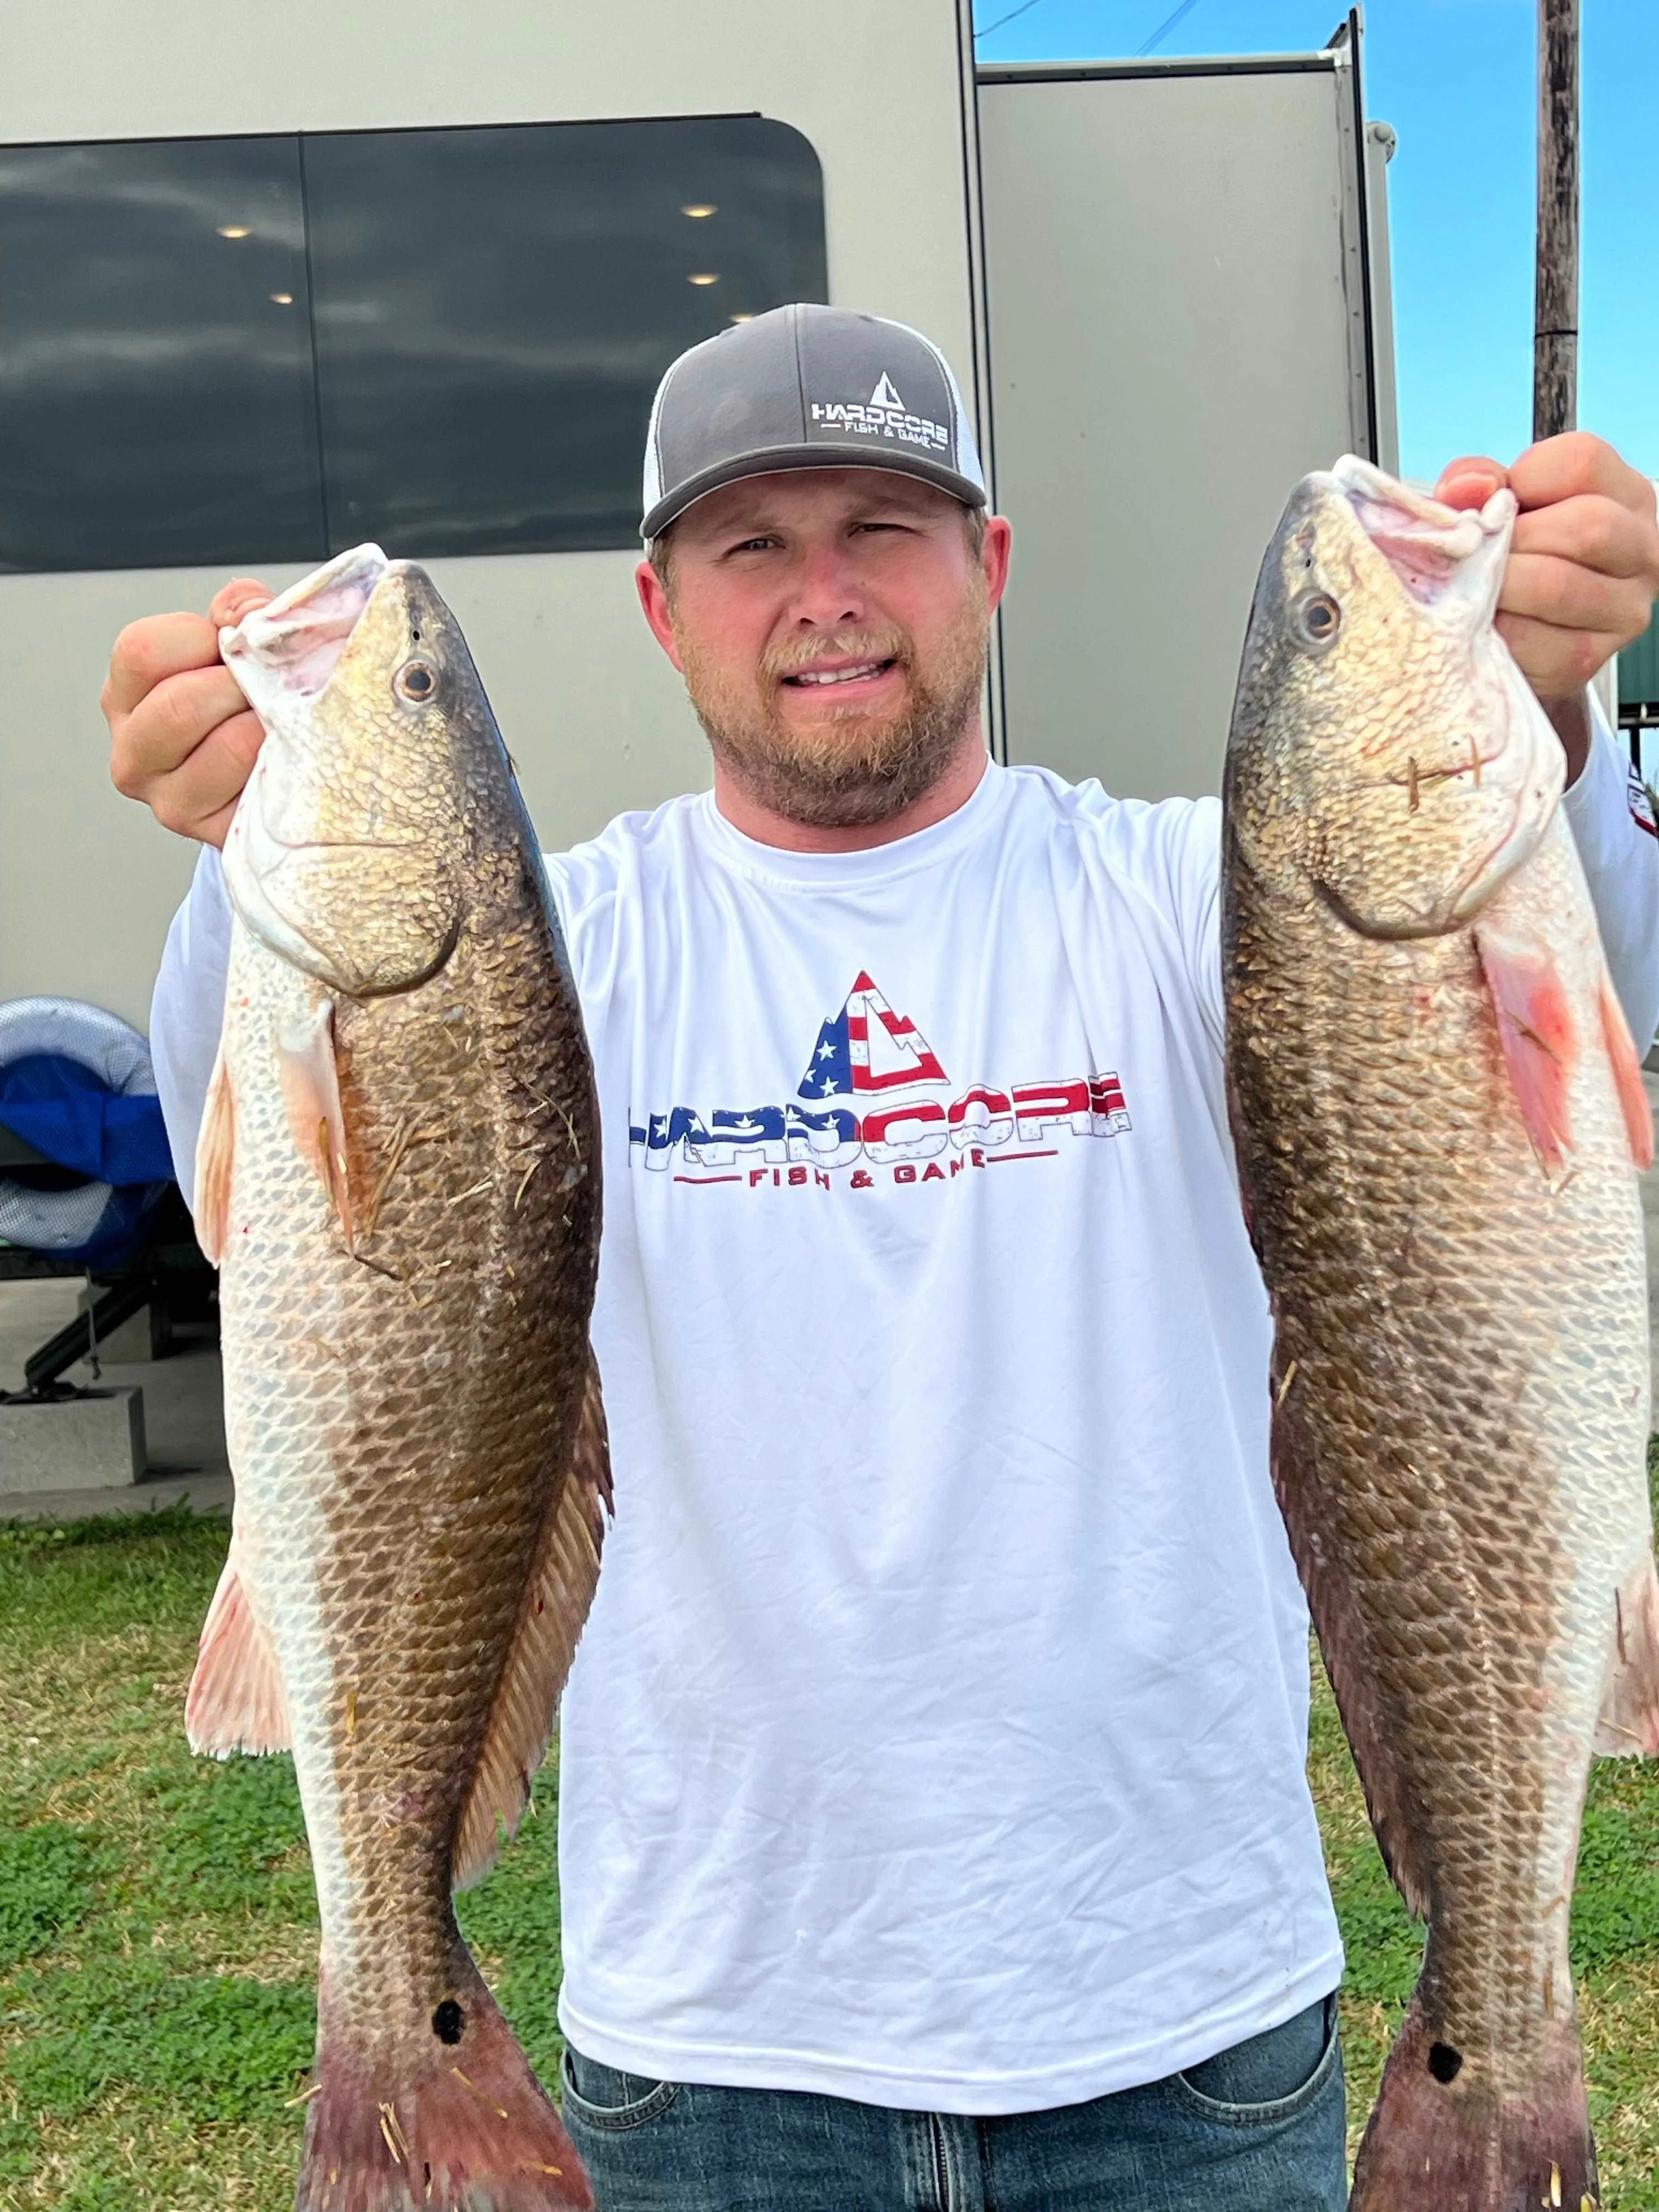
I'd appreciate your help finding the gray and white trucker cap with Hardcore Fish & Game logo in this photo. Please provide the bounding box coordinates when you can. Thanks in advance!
[639,301,984,540]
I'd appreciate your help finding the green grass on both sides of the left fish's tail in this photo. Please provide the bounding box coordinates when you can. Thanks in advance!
[0,1513,560,2212]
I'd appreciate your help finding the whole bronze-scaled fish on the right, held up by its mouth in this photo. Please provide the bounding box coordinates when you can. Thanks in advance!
[1223,462,1659,2212]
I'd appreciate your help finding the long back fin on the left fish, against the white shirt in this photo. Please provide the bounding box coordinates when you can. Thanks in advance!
[454,1354,611,1889]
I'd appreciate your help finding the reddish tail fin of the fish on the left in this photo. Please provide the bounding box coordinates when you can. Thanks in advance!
[294,1960,593,2212]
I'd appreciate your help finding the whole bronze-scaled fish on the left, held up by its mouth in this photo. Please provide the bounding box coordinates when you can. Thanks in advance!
[190,549,608,2212]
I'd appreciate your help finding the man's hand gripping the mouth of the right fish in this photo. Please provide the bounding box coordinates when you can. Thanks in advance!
[1436,429,1659,776]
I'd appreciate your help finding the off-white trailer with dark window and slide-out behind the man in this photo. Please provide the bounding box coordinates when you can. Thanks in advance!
[0,0,1393,1024]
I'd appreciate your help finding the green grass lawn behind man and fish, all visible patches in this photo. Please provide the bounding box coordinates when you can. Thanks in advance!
[0,1513,1659,2212]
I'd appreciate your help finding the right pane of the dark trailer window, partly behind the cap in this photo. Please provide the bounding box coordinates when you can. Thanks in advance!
[305,117,825,553]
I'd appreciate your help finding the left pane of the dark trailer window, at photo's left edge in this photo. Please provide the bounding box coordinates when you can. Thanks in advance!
[0,139,323,568]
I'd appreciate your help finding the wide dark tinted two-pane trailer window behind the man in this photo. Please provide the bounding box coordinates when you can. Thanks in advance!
[0,115,827,571]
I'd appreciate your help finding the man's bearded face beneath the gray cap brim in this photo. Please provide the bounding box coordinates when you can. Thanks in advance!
[639,469,1007,827]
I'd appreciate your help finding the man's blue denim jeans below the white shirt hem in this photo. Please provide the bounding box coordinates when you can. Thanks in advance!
[564,1997,1347,2212]
